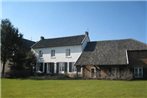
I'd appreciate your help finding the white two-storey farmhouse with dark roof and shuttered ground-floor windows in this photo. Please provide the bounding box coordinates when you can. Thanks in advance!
[32,32,90,75]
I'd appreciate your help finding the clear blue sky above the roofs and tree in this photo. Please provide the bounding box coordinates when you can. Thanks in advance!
[2,1,147,43]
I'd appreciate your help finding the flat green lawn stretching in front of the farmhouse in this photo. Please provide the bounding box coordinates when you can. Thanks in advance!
[1,79,147,98]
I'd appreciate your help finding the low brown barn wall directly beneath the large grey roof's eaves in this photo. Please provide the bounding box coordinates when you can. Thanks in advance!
[83,65,133,80]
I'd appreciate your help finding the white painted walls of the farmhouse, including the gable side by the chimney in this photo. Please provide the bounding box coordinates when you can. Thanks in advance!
[32,34,90,74]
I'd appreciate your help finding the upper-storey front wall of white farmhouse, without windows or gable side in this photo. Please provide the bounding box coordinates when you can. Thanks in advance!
[33,45,82,63]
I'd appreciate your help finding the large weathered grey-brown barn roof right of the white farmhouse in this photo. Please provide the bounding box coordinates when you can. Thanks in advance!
[75,39,147,65]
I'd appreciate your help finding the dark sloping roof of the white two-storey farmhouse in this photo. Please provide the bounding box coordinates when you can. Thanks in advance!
[32,35,85,48]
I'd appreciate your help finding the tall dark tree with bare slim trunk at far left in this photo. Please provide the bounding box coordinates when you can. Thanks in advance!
[1,19,22,76]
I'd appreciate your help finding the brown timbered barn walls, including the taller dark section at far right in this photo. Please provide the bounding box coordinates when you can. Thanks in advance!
[83,50,147,80]
